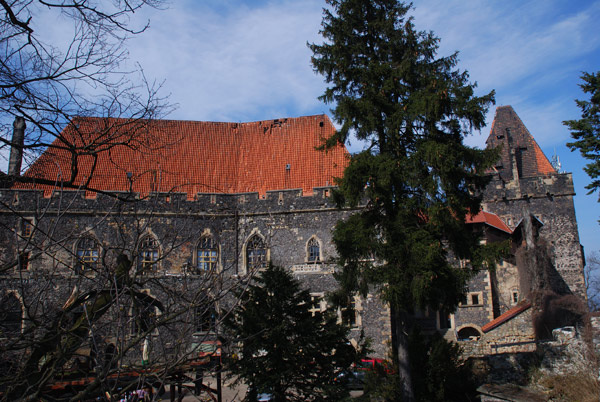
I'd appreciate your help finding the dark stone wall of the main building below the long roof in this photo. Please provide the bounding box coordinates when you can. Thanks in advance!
[0,188,391,357]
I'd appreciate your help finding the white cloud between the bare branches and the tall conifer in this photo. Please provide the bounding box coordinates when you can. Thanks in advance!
[126,1,327,121]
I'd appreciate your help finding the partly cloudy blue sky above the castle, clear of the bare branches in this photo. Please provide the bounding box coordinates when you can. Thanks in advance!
[12,0,600,253]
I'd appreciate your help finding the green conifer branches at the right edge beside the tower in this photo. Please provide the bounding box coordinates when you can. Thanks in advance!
[563,72,600,199]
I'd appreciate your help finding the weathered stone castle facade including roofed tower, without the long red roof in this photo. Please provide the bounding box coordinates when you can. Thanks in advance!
[0,107,585,357]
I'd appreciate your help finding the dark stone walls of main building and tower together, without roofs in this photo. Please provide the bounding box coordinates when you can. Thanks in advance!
[0,170,585,362]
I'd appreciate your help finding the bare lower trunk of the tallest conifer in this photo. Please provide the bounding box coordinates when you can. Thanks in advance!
[390,306,415,402]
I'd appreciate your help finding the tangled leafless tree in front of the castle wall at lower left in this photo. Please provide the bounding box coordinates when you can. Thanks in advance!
[0,191,247,400]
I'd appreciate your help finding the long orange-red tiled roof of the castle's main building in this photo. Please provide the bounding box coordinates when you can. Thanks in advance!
[20,115,348,197]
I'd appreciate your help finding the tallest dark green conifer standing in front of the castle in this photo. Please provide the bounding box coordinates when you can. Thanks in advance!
[309,0,498,401]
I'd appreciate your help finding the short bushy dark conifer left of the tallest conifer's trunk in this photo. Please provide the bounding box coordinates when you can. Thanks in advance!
[225,266,357,401]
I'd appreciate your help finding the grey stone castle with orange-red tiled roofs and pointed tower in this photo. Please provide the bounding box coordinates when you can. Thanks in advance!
[0,106,585,356]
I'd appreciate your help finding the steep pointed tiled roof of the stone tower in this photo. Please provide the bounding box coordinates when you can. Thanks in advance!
[486,106,556,180]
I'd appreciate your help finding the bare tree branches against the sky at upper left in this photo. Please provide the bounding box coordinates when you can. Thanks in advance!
[0,0,169,187]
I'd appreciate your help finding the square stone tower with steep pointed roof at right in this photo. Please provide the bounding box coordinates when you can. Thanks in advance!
[483,106,586,299]
